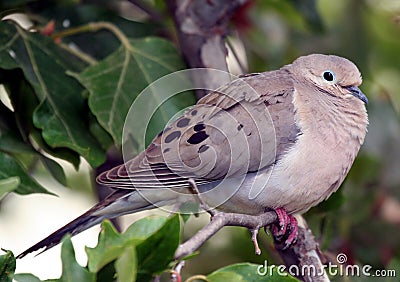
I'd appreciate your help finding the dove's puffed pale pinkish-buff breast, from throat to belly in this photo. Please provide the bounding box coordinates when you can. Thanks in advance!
[250,86,368,212]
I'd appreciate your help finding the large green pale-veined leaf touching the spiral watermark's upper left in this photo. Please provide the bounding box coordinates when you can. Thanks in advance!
[75,38,194,145]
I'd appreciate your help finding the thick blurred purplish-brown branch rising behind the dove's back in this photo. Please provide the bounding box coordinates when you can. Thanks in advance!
[166,0,247,99]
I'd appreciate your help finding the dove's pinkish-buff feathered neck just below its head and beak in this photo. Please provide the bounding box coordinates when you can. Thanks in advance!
[293,83,368,149]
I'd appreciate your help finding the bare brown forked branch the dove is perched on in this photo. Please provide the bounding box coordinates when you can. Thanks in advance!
[174,181,329,282]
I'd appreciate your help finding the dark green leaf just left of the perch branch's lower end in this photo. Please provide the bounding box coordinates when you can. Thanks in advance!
[136,214,180,281]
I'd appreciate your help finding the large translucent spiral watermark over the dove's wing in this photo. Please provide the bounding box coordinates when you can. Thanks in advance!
[122,69,276,214]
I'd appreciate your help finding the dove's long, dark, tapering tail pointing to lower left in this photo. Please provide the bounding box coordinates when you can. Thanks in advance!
[17,189,154,258]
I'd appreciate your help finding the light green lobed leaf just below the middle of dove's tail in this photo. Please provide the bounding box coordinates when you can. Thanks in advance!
[86,220,126,273]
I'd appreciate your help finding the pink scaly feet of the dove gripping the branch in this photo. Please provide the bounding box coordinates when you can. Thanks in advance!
[271,208,299,249]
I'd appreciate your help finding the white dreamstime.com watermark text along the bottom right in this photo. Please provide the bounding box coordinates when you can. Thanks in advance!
[257,253,397,277]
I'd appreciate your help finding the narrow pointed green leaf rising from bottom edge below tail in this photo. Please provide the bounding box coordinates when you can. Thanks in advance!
[59,236,95,282]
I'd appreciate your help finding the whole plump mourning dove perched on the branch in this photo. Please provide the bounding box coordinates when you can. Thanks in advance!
[19,54,368,257]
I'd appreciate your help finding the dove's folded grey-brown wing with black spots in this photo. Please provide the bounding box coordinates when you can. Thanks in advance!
[98,69,299,189]
